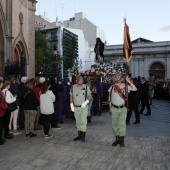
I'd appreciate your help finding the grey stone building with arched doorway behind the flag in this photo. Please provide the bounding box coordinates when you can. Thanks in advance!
[104,38,170,79]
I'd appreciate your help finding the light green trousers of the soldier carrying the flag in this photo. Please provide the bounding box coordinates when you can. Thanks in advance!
[112,107,127,136]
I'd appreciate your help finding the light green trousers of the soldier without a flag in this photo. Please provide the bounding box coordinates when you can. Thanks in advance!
[74,105,88,132]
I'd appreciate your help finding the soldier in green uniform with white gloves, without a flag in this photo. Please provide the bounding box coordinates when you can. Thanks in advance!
[70,76,91,142]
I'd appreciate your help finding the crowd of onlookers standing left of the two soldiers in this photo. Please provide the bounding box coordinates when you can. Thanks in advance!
[0,76,101,145]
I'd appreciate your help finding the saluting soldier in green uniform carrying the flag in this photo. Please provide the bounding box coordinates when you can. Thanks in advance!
[108,73,137,147]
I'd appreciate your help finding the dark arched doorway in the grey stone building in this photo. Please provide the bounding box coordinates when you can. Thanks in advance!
[149,62,165,79]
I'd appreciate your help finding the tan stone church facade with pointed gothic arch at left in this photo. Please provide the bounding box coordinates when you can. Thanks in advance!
[0,0,36,78]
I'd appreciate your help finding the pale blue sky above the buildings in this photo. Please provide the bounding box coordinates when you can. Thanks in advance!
[36,0,170,45]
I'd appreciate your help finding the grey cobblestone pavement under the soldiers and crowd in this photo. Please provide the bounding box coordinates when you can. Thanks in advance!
[0,100,170,170]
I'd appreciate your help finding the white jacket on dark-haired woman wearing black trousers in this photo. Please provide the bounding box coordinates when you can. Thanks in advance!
[40,90,55,115]
